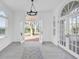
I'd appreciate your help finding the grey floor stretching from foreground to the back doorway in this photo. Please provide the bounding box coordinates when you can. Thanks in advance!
[0,42,76,59]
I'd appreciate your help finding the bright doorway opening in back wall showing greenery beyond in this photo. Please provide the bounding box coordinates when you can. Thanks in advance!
[23,21,40,42]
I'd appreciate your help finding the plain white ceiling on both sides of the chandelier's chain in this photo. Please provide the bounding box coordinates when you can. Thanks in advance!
[2,0,63,11]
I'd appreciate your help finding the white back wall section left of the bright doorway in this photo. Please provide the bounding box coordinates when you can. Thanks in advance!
[12,11,25,42]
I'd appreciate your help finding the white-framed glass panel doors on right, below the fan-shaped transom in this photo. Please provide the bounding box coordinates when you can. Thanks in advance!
[60,16,79,54]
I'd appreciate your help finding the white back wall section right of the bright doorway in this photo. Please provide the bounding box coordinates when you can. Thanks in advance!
[38,11,53,41]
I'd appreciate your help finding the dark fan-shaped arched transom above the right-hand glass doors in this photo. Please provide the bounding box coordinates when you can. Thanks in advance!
[61,1,79,17]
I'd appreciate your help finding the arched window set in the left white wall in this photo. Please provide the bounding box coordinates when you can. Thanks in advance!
[0,11,6,38]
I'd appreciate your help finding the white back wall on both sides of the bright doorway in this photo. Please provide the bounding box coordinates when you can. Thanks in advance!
[13,11,53,42]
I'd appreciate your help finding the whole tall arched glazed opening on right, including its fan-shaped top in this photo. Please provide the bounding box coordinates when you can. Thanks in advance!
[59,1,79,57]
